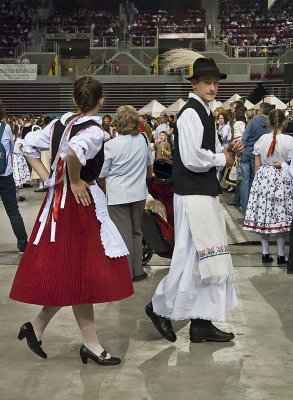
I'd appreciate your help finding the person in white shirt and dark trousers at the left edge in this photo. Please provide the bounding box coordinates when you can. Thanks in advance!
[0,103,27,253]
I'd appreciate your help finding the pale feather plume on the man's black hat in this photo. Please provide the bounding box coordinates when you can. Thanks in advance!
[162,49,205,70]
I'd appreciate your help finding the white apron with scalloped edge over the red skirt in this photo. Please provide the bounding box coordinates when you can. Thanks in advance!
[90,185,129,258]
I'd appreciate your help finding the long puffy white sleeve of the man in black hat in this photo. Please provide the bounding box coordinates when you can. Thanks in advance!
[177,108,226,173]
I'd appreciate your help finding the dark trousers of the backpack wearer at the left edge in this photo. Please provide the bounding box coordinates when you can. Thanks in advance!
[0,174,27,251]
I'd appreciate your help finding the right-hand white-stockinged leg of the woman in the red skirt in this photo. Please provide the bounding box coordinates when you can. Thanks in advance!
[72,304,110,358]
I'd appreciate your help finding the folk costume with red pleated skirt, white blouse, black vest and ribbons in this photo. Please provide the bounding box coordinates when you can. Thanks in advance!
[10,113,133,306]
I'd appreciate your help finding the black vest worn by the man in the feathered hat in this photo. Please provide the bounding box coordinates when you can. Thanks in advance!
[172,97,222,196]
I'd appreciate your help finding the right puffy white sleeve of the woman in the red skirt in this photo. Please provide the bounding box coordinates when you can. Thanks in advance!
[60,125,104,165]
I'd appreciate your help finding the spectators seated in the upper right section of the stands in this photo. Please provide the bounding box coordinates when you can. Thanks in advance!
[219,0,293,57]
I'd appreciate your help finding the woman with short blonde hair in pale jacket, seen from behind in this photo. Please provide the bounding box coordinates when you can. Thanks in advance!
[100,105,152,281]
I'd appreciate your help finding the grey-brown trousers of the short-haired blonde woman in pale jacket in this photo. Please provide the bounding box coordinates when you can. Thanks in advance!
[108,200,145,276]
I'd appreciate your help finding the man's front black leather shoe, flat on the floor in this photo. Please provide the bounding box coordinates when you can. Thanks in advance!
[189,319,235,343]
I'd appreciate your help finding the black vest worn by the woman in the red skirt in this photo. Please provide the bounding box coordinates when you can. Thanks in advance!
[51,120,104,181]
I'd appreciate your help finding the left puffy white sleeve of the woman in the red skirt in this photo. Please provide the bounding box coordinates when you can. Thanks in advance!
[19,119,57,158]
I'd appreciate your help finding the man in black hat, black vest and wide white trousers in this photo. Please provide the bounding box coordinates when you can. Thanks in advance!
[145,58,243,343]
